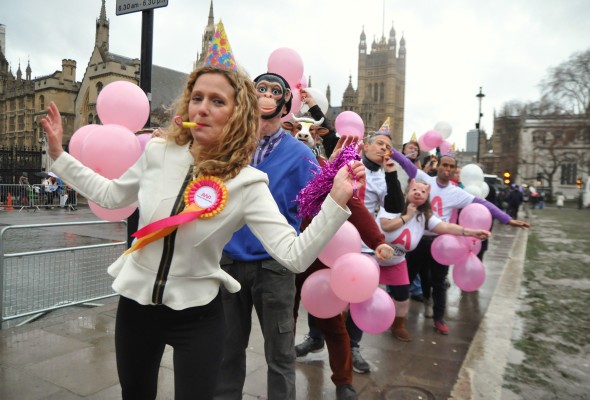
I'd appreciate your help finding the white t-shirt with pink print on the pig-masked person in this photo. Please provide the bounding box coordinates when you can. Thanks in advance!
[377,209,442,266]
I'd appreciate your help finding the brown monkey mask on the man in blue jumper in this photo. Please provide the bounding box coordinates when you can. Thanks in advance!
[254,72,293,119]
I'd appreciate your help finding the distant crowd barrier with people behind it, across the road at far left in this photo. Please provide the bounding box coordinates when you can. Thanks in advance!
[0,184,78,211]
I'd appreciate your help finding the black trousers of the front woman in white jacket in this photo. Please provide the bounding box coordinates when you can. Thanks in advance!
[115,295,225,400]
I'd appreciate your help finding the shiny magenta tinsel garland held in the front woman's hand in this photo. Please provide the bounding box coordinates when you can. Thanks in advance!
[295,144,361,218]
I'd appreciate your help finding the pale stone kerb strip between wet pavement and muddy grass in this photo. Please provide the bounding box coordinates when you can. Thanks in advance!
[450,229,528,400]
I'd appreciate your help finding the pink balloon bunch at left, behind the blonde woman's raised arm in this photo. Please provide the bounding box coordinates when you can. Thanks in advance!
[69,81,150,221]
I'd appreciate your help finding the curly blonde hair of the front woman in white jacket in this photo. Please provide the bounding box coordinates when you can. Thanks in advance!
[166,66,259,180]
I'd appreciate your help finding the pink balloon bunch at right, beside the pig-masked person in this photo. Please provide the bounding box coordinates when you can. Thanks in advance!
[430,203,492,292]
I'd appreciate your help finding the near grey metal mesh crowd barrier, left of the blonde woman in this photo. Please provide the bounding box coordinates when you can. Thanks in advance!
[0,221,127,329]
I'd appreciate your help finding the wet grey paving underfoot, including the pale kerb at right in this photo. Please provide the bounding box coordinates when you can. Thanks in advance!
[0,206,527,400]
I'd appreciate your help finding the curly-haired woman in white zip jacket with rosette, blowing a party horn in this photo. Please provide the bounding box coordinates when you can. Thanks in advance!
[42,67,364,400]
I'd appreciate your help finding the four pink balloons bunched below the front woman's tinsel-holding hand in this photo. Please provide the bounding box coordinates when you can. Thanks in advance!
[301,221,395,333]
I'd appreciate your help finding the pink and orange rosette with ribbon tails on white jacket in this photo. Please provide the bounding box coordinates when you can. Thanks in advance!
[125,176,227,254]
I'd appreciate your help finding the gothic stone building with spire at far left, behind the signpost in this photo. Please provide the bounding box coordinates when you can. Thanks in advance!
[0,0,188,152]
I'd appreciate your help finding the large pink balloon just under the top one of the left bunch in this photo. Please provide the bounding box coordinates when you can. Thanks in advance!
[82,125,141,179]
